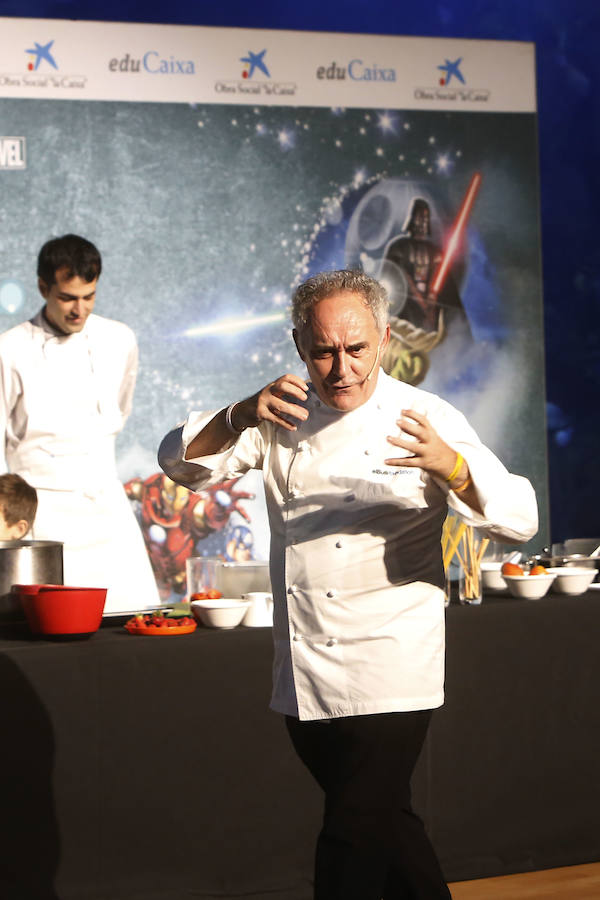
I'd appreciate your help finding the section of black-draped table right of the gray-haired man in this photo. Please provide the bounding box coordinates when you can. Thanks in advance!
[413,591,600,881]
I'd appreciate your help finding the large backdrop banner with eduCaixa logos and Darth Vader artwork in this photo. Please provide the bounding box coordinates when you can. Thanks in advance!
[0,19,548,601]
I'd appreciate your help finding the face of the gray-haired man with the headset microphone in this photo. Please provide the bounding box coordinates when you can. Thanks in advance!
[294,291,390,412]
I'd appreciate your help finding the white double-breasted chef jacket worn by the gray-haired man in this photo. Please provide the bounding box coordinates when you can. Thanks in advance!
[159,371,537,719]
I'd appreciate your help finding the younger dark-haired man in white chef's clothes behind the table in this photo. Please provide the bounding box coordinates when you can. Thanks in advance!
[0,235,160,612]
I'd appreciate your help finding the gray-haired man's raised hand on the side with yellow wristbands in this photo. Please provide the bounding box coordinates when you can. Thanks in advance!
[385,409,460,483]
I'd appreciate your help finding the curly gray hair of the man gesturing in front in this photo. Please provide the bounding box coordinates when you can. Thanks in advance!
[292,269,389,335]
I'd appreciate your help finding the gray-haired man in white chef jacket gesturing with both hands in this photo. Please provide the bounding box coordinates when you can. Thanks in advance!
[159,271,537,900]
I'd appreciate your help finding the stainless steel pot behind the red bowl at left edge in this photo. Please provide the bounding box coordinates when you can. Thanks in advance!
[0,541,63,622]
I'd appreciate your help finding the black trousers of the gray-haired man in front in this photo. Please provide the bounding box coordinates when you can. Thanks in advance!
[286,710,450,900]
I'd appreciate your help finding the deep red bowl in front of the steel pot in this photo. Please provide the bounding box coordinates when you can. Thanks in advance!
[15,584,107,635]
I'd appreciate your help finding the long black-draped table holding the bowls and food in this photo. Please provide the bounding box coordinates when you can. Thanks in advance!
[0,591,600,900]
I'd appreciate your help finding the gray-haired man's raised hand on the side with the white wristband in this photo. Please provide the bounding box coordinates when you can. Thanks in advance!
[231,374,308,431]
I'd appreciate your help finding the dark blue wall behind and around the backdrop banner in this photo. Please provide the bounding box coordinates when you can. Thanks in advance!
[0,0,600,541]
